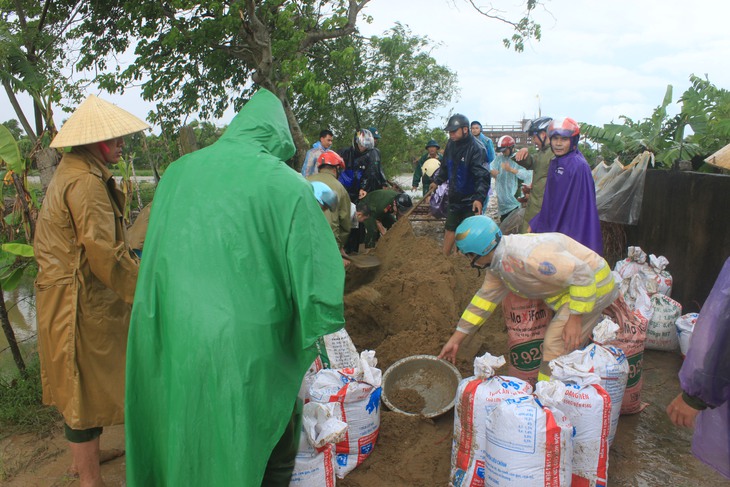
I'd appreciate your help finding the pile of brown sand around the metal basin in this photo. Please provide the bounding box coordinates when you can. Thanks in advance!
[337,221,506,487]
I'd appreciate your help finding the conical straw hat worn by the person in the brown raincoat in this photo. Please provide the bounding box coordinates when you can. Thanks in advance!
[51,95,150,147]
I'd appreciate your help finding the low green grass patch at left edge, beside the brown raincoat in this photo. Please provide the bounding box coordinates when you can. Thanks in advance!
[0,355,61,436]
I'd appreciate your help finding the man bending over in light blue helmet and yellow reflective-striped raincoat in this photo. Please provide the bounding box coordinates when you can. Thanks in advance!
[439,215,618,380]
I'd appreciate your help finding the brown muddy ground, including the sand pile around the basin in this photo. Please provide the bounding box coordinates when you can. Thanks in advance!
[0,222,730,487]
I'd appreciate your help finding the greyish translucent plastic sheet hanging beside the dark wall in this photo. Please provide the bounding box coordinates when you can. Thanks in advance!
[593,151,654,225]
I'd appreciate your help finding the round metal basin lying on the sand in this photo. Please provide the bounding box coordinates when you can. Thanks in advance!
[383,355,461,418]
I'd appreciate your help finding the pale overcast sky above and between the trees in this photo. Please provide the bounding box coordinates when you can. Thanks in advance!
[0,0,730,133]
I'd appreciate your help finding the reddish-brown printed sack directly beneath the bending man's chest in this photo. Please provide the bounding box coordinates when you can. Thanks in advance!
[502,293,553,387]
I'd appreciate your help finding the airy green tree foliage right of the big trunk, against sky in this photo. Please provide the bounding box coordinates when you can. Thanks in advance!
[292,24,457,175]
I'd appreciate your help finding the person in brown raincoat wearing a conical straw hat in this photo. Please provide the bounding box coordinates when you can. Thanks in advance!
[34,95,149,487]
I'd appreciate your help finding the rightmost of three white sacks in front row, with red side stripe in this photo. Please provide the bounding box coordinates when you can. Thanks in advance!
[546,355,611,487]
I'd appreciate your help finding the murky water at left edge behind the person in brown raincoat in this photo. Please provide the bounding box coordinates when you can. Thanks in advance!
[0,278,36,378]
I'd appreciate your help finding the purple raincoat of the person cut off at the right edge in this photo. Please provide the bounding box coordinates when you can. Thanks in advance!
[679,259,730,478]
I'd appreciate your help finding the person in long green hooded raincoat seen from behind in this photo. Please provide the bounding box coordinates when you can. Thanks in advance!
[125,89,345,487]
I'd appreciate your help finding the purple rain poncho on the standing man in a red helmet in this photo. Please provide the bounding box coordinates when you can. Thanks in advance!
[530,150,603,255]
